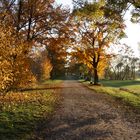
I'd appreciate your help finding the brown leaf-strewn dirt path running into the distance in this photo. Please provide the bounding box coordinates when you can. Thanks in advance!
[37,81,140,140]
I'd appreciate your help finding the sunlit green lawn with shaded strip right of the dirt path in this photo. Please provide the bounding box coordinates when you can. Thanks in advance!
[80,80,140,108]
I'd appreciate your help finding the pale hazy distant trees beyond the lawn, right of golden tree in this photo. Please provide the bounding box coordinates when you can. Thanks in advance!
[105,44,138,80]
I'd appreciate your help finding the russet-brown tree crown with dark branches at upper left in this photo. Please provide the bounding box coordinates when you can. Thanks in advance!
[0,0,69,45]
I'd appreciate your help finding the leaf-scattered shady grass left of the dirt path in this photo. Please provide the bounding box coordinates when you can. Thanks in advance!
[0,81,60,140]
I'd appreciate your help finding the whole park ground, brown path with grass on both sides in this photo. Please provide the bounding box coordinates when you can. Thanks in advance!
[0,80,140,140]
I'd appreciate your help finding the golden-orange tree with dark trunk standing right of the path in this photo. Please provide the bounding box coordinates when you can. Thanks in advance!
[73,1,124,85]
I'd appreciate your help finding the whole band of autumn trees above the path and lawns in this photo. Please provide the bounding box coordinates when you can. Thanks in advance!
[0,0,140,91]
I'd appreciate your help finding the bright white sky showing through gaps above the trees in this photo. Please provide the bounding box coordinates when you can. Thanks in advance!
[56,0,140,57]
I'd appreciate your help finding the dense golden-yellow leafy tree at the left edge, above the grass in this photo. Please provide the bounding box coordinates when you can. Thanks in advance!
[0,24,35,91]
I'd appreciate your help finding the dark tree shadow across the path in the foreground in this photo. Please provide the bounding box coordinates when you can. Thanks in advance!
[45,118,112,140]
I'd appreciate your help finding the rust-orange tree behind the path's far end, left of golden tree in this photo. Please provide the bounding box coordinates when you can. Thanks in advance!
[46,37,69,79]
